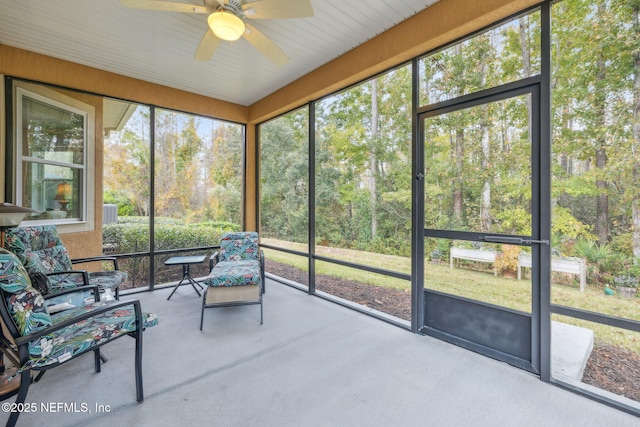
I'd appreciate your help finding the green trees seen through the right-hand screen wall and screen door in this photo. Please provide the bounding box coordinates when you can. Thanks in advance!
[261,0,640,274]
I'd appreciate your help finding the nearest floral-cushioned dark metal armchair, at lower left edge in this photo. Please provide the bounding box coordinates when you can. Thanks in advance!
[0,248,158,426]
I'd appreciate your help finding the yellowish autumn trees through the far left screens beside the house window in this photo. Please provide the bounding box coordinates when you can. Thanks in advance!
[104,106,243,223]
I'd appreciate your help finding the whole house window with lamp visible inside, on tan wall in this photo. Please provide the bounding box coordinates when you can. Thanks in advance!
[15,84,95,231]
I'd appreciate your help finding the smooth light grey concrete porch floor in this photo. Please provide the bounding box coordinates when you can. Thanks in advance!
[0,281,640,427]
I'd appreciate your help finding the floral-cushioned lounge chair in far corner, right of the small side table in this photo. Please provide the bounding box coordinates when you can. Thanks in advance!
[200,232,265,330]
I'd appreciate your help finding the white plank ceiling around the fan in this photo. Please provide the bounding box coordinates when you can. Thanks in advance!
[0,0,437,106]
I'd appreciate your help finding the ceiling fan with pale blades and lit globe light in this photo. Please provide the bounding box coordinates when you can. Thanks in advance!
[120,0,313,67]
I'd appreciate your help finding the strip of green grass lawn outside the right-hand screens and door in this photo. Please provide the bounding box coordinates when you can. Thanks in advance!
[263,239,640,353]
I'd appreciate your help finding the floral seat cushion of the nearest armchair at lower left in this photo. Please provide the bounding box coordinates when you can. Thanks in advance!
[29,302,158,367]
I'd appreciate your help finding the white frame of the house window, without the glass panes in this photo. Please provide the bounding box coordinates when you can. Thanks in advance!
[14,82,96,233]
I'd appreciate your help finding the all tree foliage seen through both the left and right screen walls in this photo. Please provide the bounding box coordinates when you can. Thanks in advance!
[99,0,640,298]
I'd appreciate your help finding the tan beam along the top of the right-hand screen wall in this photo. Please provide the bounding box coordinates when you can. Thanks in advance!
[249,0,540,123]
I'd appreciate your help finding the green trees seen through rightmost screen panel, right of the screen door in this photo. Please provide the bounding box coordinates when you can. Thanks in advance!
[552,0,638,244]
